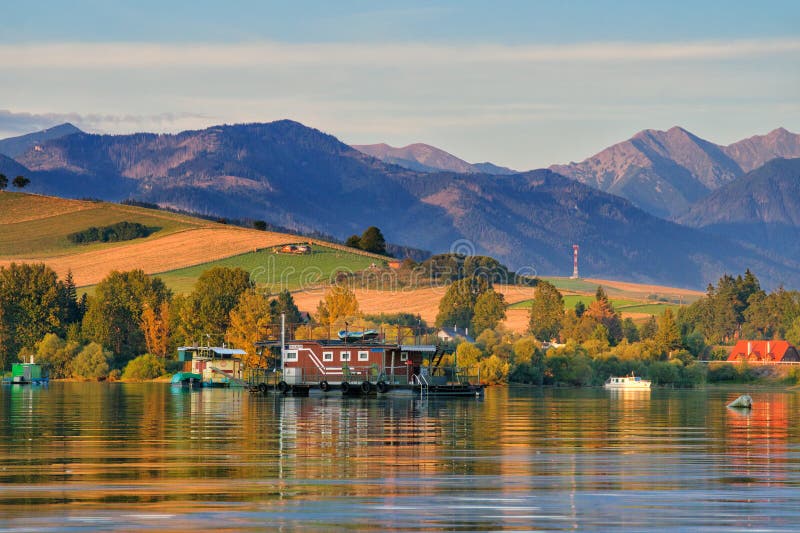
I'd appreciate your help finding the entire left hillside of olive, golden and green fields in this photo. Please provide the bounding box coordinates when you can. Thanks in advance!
[0,192,372,286]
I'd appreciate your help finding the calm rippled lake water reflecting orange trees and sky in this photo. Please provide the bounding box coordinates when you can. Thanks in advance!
[0,383,800,531]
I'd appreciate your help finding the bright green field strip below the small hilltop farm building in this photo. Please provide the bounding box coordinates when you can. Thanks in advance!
[156,245,379,294]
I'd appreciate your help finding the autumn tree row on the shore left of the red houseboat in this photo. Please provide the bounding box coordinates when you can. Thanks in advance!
[0,263,300,379]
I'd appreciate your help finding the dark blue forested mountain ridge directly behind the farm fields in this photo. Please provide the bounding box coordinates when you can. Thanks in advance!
[0,120,800,288]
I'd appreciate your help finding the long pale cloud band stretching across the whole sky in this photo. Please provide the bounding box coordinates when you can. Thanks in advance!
[0,39,800,69]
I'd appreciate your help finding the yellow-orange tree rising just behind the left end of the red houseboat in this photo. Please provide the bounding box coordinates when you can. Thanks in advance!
[225,289,274,367]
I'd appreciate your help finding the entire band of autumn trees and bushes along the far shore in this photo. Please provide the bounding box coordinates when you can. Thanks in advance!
[0,258,800,387]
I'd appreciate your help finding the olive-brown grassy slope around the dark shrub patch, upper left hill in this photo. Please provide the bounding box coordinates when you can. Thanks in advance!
[0,192,205,258]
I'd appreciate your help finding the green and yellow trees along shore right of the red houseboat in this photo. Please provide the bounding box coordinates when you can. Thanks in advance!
[424,270,800,386]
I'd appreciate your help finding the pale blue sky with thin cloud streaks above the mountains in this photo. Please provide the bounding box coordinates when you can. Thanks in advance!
[0,0,800,170]
